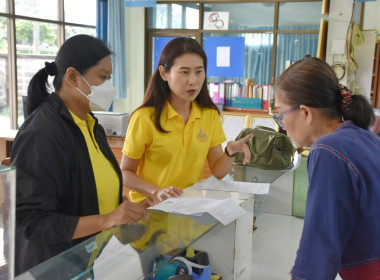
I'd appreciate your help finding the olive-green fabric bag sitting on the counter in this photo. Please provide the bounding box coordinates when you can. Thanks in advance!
[235,126,296,170]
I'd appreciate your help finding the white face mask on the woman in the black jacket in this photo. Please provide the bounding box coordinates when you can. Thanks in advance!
[76,74,116,111]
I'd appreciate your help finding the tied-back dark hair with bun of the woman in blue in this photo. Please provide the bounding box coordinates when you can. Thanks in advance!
[275,57,374,129]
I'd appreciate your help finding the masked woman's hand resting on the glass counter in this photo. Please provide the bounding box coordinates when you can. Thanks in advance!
[105,200,148,228]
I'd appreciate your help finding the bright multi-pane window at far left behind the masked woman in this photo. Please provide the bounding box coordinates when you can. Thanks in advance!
[0,0,96,129]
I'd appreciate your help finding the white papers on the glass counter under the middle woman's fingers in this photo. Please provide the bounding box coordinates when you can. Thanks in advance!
[148,196,246,225]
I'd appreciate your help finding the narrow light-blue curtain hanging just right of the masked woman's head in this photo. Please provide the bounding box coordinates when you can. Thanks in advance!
[107,0,126,99]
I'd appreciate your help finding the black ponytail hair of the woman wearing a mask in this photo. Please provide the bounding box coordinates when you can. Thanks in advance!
[26,34,112,114]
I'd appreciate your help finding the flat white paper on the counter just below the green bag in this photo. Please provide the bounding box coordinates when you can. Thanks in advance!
[191,179,270,194]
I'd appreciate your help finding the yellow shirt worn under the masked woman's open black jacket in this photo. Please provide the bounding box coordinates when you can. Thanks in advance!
[70,111,120,214]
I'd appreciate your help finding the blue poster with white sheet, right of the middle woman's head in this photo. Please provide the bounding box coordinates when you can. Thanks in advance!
[203,37,245,77]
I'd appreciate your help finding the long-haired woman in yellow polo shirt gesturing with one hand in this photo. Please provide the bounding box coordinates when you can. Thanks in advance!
[121,37,252,204]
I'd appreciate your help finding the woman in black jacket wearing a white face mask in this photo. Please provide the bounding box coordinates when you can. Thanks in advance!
[11,35,146,275]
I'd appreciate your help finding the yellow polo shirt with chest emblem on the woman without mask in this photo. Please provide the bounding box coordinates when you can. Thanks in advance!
[123,101,226,202]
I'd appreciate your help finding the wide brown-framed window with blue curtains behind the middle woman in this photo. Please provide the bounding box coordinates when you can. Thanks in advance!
[146,0,324,90]
